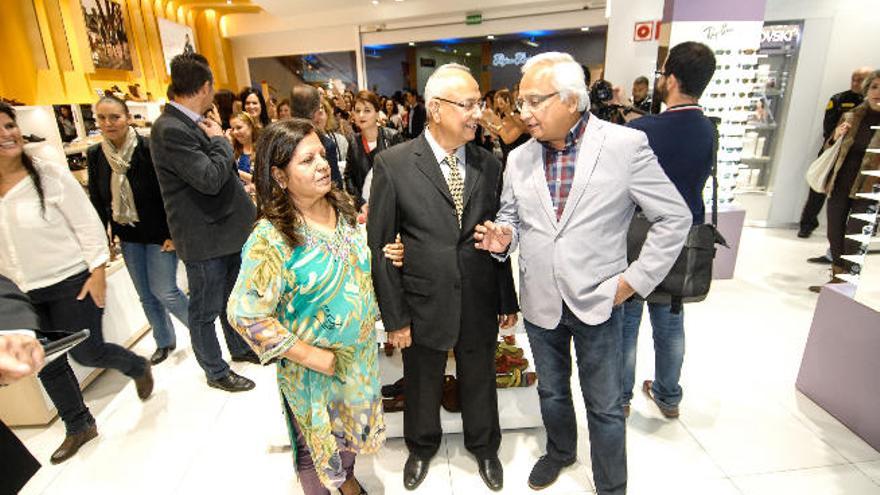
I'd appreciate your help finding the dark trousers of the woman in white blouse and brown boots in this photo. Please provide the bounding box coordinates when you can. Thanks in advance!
[28,271,147,434]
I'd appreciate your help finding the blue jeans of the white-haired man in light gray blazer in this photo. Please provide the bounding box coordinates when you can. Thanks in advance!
[524,306,627,495]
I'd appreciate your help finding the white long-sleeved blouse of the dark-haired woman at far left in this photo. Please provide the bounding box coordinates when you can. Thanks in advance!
[0,159,110,292]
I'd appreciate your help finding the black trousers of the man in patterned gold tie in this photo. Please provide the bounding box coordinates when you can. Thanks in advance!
[403,334,501,459]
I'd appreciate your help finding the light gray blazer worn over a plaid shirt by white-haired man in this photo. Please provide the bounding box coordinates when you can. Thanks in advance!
[496,115,693,328]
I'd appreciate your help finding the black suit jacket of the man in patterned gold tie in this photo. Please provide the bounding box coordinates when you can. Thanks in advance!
[367,135,518,350]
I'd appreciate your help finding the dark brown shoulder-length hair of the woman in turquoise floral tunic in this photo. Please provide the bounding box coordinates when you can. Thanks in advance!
[253,118,356,248]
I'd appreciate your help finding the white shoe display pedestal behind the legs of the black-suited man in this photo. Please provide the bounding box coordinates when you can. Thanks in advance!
[379,330,544,438]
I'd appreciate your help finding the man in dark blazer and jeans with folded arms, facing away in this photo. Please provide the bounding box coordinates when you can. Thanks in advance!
[150,53,257,392]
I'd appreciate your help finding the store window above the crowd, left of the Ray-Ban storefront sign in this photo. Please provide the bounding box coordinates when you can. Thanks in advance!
[248,51,357,100]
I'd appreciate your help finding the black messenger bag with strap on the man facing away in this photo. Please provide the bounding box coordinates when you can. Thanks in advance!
[627,118,730,314]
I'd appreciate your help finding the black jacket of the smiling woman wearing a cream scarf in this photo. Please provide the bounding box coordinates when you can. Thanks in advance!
[86,135,171,244]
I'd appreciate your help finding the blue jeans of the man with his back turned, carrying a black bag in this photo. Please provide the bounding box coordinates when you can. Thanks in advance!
[622,299,684,408]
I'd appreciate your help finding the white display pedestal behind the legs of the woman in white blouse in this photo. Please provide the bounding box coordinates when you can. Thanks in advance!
[0,260,150,426]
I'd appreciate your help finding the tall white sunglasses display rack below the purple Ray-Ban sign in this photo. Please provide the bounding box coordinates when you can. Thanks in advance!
[700,48,762,206]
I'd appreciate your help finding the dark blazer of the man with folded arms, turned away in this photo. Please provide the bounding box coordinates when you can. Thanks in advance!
[150,105,256,262]
